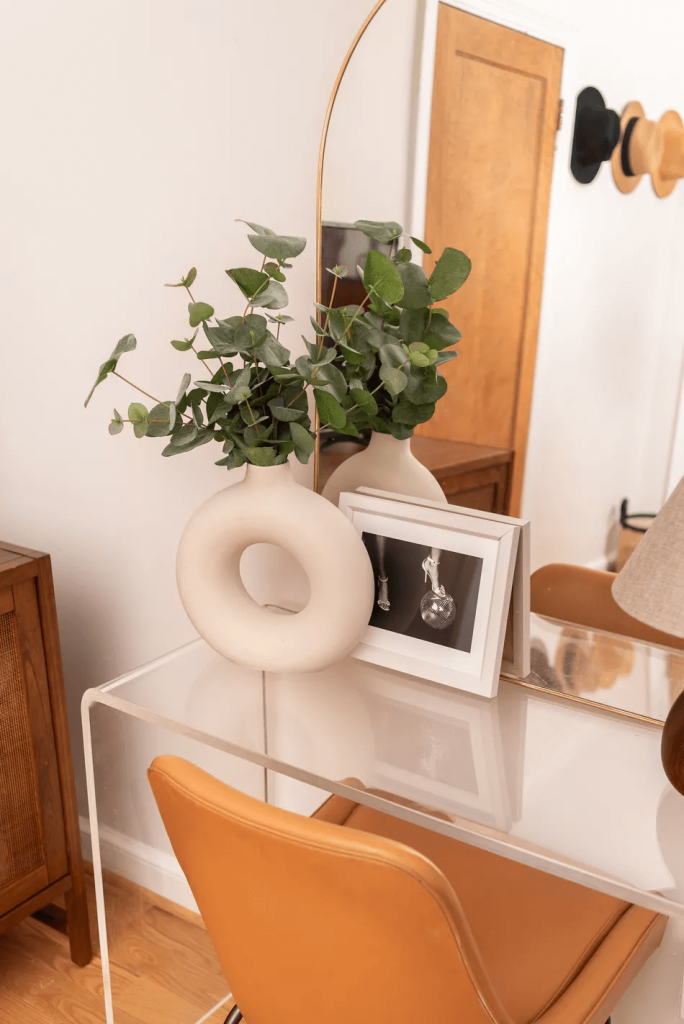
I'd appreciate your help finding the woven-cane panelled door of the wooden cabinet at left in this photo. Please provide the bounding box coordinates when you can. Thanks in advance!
[0,580,68,916]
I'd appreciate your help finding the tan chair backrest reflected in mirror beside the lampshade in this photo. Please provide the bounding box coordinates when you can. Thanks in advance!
[529,562,684,650]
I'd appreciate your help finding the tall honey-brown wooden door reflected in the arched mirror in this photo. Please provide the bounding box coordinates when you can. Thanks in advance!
[418,3,563,515]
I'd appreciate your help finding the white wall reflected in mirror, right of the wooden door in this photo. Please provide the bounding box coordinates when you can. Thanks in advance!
[523,0,684,564]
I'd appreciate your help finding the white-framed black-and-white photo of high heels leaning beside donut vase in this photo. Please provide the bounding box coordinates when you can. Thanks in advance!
[340,492,519,697]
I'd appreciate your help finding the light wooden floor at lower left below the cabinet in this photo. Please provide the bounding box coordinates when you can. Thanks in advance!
[0,874,231,1024]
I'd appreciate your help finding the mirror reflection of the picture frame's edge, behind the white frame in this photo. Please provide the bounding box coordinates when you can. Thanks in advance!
[358,487,531,679]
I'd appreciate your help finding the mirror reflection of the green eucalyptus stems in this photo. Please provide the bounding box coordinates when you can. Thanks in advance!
[309,220,471,439]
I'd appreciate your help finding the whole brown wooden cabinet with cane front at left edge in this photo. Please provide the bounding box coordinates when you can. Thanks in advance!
[0,544,91,966]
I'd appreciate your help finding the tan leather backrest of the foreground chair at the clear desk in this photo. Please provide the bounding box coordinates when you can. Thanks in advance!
[148,757,511,1024]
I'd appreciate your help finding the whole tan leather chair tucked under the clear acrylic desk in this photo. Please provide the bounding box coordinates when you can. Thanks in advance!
[148,757,666,1024]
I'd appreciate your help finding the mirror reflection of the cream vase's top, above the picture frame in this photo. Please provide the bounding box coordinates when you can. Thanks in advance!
[323,432,446,505]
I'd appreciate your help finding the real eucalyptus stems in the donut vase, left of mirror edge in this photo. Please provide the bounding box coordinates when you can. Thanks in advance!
[85,221,323,469]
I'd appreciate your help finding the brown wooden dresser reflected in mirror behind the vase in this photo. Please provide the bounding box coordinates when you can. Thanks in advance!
[319,435,513,515]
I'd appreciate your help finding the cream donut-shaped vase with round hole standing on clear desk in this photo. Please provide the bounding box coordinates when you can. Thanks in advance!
[176,463,375,672]
